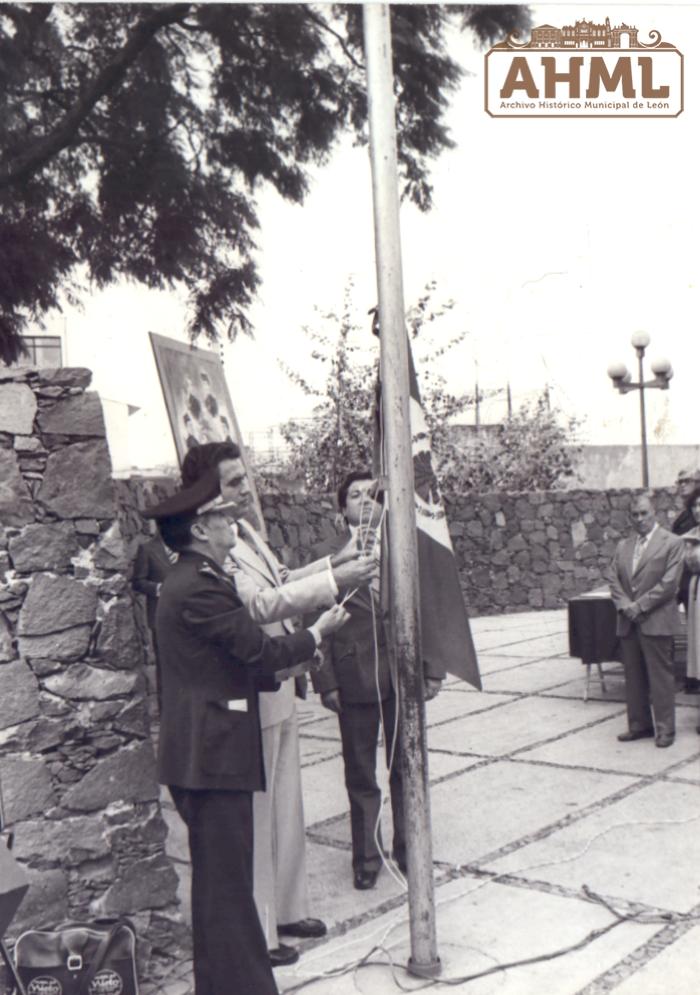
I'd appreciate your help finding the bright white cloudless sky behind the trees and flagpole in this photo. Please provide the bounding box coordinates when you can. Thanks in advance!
[42,3,700,467]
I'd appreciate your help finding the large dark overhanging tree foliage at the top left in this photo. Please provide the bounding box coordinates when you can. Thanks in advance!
[0,3,528,361]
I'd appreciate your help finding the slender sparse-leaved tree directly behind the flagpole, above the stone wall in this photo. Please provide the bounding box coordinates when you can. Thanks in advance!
[266,280,492,494]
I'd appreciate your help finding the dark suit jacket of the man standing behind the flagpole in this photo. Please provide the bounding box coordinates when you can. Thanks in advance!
[311,531,445,704]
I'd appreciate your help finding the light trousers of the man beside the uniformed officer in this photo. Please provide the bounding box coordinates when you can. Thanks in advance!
[253,708,309,949]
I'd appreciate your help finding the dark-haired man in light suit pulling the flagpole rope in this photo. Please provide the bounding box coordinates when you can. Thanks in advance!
[182,443,376,966]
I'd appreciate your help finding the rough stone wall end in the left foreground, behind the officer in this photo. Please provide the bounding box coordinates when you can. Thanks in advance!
[0,369,187,981]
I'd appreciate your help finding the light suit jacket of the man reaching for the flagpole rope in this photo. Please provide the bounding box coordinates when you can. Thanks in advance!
[227,521,335,728]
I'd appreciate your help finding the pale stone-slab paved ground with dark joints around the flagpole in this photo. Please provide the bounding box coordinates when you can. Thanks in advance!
[153,611,700,995]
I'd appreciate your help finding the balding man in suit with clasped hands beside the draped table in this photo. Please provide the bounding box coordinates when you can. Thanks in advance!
[610,494,683,748]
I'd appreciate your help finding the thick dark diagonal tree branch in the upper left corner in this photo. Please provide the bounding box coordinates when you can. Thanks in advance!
[0,4,191,190]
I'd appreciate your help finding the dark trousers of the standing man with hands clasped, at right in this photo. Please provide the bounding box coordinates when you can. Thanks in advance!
[620,625,676,736]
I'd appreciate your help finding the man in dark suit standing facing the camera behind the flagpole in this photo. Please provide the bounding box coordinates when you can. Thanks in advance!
[311,470,445,890]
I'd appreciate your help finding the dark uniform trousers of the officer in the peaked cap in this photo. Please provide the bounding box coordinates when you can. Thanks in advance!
[170,786,277,995]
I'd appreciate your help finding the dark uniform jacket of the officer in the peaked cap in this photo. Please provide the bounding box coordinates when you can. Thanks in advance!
[156,551,315,791]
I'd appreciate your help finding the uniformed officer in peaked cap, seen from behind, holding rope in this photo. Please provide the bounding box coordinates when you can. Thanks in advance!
[150,473,347,995]
